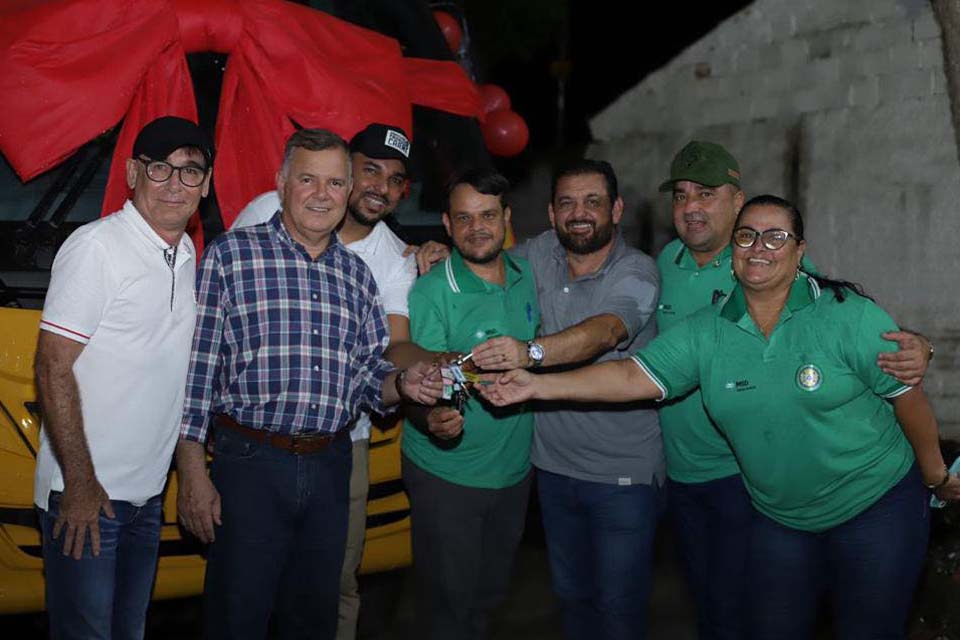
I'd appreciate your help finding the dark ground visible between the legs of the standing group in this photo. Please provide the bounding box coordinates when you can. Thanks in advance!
[0,507,960,640]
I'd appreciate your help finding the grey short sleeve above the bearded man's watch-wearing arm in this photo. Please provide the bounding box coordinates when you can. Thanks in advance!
[593,255,660,349]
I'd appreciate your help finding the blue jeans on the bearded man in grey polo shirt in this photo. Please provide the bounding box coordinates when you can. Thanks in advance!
[537,469,664,640]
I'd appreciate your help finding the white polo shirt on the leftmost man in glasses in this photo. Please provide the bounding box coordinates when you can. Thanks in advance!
[34,200,196,509]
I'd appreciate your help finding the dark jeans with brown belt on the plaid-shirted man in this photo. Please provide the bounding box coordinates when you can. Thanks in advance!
[204,429,352,640]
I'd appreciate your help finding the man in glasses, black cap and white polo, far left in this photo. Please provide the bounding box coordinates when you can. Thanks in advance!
[34,116,213,639]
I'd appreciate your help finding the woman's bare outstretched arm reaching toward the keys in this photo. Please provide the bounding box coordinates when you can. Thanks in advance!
[478,359,663,406]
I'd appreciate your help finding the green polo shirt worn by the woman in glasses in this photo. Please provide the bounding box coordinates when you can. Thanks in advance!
[634,280,914,531]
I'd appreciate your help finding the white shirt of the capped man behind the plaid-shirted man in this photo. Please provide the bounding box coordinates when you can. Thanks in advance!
[230,191,417,442]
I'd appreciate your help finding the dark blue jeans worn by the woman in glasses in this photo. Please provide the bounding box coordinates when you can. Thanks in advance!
[748,466,930,640]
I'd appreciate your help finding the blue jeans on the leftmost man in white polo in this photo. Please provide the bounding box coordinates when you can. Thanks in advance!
[39,491,163,640]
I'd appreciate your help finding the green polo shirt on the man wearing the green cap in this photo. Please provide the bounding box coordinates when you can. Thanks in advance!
[657,238,740,482]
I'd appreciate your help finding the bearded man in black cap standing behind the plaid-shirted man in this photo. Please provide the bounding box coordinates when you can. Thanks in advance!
[231,124,422,640]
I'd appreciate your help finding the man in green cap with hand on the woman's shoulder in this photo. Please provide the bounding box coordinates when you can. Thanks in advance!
[657,140,932,640]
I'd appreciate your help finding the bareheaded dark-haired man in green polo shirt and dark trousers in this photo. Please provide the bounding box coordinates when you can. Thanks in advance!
[402,169,540,640]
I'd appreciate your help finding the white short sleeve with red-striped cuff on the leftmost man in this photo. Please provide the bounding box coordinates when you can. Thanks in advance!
[40,228,116,344]
